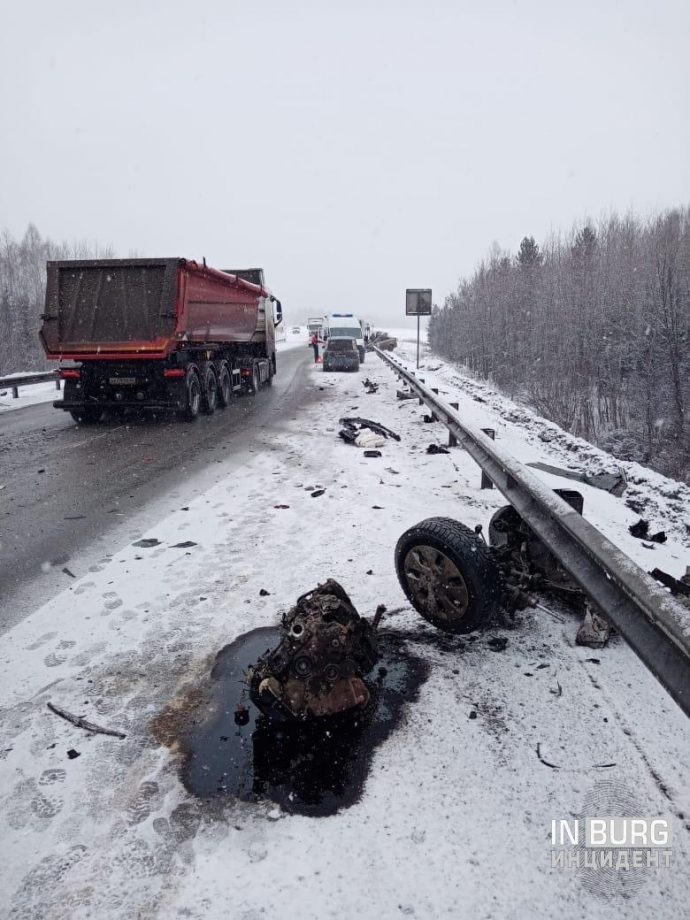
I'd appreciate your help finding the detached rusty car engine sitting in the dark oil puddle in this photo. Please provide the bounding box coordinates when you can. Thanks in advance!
[247,579,379,720]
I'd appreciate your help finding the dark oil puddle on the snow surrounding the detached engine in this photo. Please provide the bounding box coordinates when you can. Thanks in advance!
[153,627,428,817]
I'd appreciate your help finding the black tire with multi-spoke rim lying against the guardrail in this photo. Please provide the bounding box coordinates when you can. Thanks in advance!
[395,518,503,633]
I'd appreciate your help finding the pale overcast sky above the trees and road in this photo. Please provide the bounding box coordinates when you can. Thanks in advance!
[0,0,690,325]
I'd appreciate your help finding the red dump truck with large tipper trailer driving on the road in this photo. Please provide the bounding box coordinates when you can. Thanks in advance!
[40,259,282,422]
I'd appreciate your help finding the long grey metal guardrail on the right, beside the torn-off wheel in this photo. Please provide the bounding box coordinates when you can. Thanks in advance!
[374,348,690,716]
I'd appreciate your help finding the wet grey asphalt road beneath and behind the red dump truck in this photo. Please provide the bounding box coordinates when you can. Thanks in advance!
[0,348,318,633]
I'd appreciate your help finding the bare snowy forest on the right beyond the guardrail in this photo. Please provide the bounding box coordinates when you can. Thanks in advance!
[429,207,690,481]
